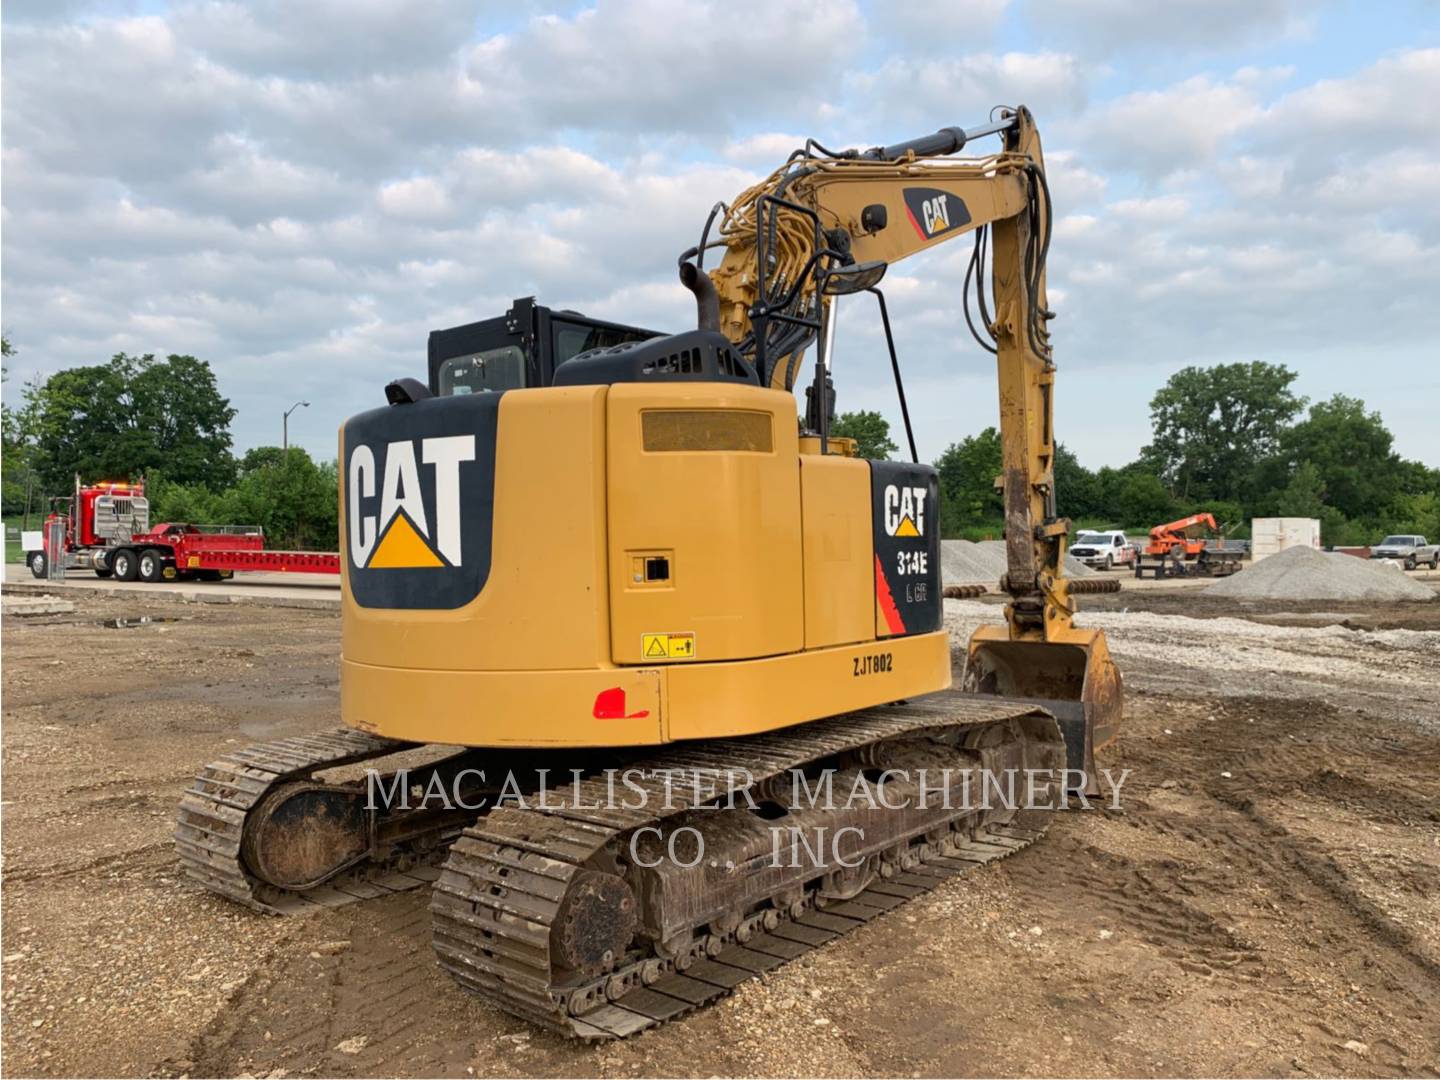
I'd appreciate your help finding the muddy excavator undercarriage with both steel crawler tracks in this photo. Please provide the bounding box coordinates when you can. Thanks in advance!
[176,693,1066,1040]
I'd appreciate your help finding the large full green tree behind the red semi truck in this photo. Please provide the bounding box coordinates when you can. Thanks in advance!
[29,353,235,488]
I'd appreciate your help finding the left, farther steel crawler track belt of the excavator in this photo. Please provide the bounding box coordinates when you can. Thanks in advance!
[174,727,436,914]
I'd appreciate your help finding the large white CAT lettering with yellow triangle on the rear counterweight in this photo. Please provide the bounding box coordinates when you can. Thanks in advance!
[346,435,475,570]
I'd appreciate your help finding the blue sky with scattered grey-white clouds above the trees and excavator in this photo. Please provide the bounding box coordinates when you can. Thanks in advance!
[0,0,1440,468]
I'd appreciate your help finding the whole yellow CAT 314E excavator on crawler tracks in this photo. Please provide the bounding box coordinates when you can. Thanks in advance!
[176,108,1122,1040]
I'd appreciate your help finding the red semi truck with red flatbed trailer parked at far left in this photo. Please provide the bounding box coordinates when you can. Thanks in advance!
[24,477,340,582]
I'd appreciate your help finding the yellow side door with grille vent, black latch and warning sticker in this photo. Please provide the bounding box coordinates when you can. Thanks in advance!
[606,383,805,664]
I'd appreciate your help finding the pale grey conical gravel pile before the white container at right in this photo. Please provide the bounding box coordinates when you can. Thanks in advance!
[1205,547,1436,600]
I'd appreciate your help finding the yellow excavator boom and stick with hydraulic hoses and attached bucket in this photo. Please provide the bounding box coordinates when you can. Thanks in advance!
[681,108,1122,779]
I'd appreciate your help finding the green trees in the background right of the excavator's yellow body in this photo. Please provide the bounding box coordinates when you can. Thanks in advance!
[834,361,1440,544]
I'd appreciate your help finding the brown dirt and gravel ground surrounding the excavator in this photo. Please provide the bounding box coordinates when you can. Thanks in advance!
[0,589,1440,1077]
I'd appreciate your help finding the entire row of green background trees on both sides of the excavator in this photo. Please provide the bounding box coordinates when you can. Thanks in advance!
[0,347,1440,550]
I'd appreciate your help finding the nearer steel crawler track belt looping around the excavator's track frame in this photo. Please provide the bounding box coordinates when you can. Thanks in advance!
[431,691,1064,1041]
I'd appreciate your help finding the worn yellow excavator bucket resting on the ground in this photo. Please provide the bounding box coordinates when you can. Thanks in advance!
[960,626,1123,795]
